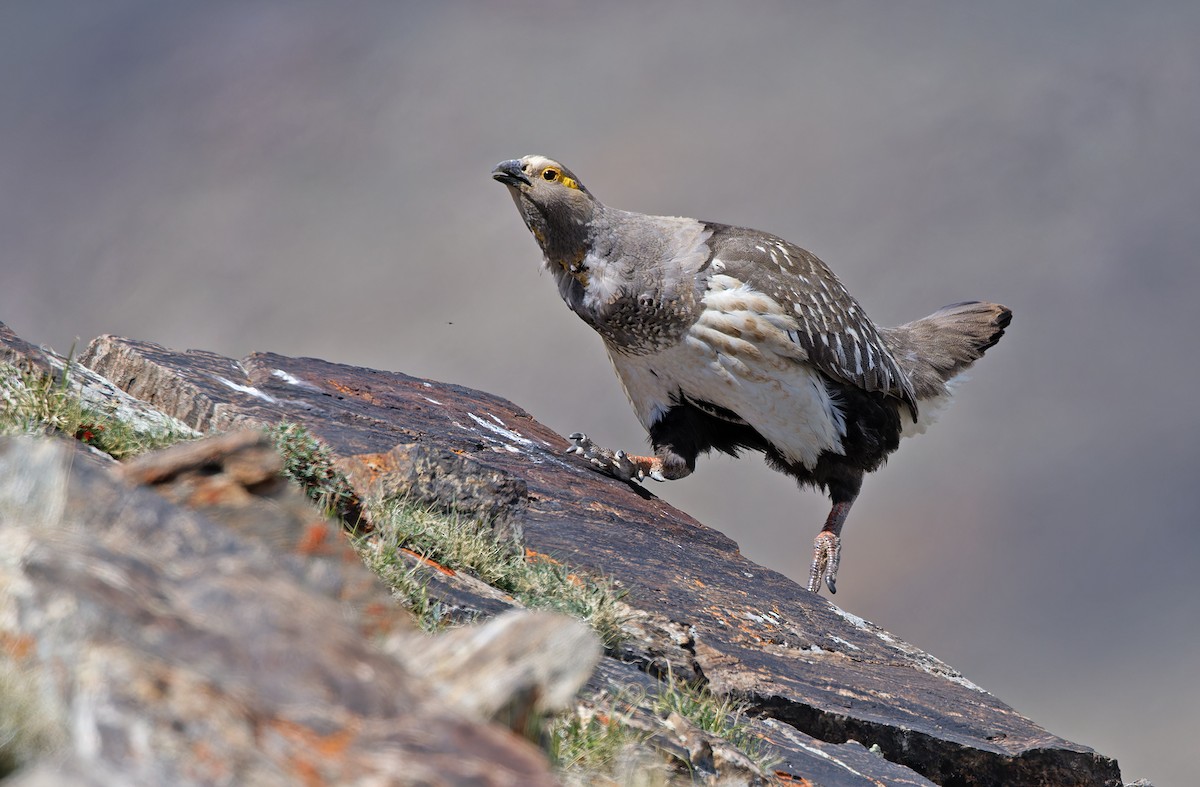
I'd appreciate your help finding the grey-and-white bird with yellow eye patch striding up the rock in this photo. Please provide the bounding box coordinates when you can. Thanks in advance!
[492,155,1013,594]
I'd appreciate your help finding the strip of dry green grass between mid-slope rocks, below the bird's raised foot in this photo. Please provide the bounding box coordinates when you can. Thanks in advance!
[370,500,623,647]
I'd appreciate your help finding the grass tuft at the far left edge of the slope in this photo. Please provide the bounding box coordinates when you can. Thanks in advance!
[0,360,191,459]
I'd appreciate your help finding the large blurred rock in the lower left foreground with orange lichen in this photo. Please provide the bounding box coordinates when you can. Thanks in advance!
[0,438,556,786]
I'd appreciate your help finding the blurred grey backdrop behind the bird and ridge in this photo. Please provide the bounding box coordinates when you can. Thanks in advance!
[0,0,1200,786]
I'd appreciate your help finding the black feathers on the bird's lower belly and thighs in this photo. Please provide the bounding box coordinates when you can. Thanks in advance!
[650,376,901,493]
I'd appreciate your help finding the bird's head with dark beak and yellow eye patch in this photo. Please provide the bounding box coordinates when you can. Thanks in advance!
[492,156,599,262]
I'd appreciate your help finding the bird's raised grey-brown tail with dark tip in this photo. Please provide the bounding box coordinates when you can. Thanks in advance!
[880,301,1013,401]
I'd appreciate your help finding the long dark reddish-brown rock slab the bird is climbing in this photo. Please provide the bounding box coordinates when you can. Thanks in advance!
[82,337,1121,785]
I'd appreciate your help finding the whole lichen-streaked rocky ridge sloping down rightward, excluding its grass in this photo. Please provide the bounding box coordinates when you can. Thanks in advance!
[0,325,1121,786]
